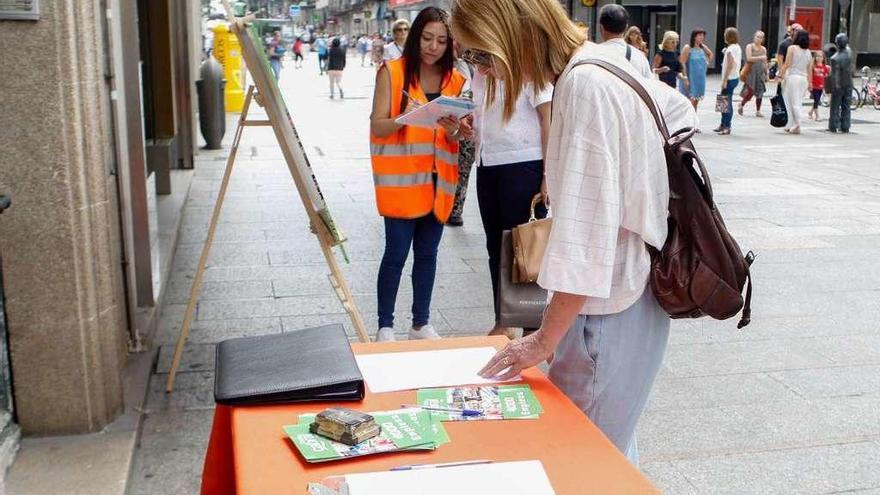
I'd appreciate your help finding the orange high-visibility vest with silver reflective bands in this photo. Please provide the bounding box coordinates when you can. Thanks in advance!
[370,58,465,223]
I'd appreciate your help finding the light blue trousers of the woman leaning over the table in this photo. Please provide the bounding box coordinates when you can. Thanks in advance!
[549,287,670,466]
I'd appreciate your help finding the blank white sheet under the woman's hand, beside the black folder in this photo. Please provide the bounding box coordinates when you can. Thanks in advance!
[355,347,520,393]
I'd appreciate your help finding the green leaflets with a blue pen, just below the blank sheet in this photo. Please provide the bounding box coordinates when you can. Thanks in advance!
[416,384,544,421]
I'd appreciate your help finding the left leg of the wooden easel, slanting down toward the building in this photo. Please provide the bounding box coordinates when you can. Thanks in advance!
[165,86,254,392]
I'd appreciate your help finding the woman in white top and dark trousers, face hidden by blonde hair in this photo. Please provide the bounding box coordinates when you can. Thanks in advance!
[463,48,553,337]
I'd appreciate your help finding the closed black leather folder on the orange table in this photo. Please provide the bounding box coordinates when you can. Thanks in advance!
[214,324,364,405]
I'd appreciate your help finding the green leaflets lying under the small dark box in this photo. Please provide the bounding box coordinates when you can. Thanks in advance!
[284,408,449,462]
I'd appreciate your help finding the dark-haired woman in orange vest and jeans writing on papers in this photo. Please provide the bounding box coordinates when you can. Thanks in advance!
[370,7,473,341]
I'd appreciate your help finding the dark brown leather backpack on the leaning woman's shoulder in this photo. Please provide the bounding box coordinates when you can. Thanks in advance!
[573,59,755,328]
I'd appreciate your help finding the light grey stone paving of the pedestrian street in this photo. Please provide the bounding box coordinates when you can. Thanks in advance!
[129,51,880,494]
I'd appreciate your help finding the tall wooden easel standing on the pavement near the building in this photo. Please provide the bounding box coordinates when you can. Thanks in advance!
[165,11,370,393]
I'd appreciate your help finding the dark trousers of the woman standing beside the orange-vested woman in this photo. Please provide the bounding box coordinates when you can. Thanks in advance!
[477,160,547,323]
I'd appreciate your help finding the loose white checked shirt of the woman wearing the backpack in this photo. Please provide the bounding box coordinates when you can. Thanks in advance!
[538,42,697,315]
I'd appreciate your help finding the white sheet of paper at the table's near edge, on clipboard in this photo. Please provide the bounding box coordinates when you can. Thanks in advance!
[345,461,556,495]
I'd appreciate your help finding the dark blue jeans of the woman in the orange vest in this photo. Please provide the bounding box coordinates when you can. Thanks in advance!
[376,213,443,328]
